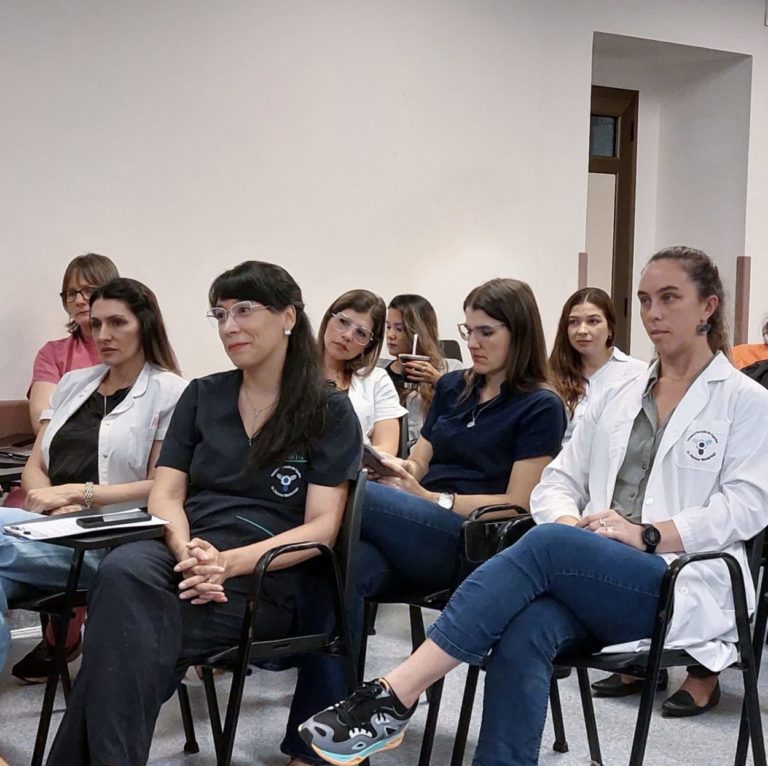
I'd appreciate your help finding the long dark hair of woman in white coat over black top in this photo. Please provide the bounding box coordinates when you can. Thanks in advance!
[89,277,179,374]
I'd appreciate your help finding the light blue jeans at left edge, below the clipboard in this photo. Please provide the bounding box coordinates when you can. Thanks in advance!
[0,508,103,670]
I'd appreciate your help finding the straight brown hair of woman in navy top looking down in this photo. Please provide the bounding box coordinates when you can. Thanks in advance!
[462,279,549,399]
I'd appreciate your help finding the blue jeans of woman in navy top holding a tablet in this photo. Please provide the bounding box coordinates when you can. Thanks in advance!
[349,482,464,647]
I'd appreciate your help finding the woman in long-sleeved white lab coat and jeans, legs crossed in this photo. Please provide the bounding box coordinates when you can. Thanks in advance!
[302,247,768,766]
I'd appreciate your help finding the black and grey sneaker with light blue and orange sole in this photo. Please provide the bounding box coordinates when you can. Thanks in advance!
[299,679,416,766]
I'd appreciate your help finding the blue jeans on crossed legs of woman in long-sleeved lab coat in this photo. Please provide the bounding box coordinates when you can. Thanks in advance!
[428,524,667,766]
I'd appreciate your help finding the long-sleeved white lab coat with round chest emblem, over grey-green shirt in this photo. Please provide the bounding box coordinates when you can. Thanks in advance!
[531,354,768,670]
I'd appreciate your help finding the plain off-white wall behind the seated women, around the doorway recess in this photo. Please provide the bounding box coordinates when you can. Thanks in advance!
[0,0,768,398]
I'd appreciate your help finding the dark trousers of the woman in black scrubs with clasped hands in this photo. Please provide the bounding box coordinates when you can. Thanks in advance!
[47,540,347,766]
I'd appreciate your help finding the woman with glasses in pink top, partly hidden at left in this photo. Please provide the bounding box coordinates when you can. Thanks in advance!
[27,253,120,433]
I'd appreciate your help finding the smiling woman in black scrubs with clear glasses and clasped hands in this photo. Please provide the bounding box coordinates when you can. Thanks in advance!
[48,261,362,766]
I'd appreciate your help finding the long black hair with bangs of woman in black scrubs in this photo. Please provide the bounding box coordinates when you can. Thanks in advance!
[208,261,328,468]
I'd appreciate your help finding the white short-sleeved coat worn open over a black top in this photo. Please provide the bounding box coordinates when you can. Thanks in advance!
[40,363,187,511]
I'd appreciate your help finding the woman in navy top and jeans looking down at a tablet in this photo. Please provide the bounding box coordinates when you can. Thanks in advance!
[352,279,566,631]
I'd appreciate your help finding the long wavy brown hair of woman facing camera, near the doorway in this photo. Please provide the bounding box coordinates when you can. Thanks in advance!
[549,287,616,415]
